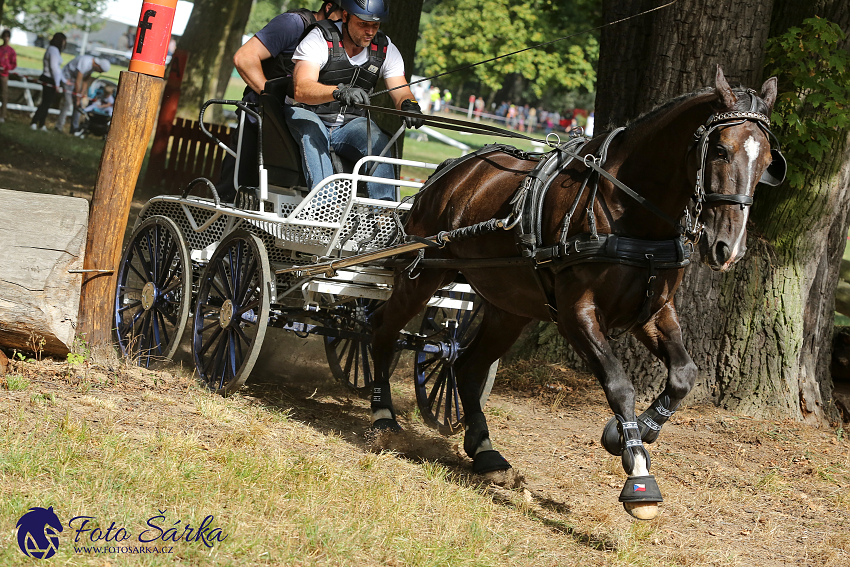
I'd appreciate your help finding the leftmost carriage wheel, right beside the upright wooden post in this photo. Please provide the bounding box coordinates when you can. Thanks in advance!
[115,216,192,368]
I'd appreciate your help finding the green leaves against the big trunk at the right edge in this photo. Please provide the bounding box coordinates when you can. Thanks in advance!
[766,17,850,187]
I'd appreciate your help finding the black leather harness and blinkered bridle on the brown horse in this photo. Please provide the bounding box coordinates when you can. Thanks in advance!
[400,90,785,328]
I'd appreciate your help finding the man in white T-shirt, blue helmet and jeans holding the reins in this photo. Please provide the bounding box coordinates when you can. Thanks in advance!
[284,0,422,200]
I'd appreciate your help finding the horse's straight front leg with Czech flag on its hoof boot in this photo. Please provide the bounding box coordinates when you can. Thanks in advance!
[558,301,663,520]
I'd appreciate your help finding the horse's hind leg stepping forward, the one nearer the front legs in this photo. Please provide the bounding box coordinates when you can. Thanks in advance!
[455,303,531,481]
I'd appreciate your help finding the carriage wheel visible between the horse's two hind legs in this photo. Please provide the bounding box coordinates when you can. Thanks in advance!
[413,302,499,435]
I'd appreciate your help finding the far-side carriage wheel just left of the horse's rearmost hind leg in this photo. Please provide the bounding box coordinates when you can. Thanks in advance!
[325,297,400,395]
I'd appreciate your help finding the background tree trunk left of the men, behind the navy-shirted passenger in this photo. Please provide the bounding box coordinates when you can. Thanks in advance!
[177,0,252,122]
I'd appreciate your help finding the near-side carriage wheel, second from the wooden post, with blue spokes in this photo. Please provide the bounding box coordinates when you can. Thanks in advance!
[192,230,272,395]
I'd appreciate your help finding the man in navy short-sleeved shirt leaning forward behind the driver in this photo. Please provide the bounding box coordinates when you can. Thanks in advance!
[216,0,342,201]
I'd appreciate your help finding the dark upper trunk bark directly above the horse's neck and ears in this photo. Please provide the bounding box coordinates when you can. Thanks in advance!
[596,0,772,131]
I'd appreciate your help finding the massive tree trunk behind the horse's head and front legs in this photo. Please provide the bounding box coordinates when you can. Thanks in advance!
[516,0,850,423]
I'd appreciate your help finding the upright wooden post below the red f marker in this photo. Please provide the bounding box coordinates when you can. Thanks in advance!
[78,71,165,347]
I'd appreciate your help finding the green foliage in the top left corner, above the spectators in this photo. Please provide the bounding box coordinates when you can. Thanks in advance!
[2,0,106,35]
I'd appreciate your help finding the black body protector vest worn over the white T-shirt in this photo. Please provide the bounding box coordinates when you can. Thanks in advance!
[299,20,389,124]
